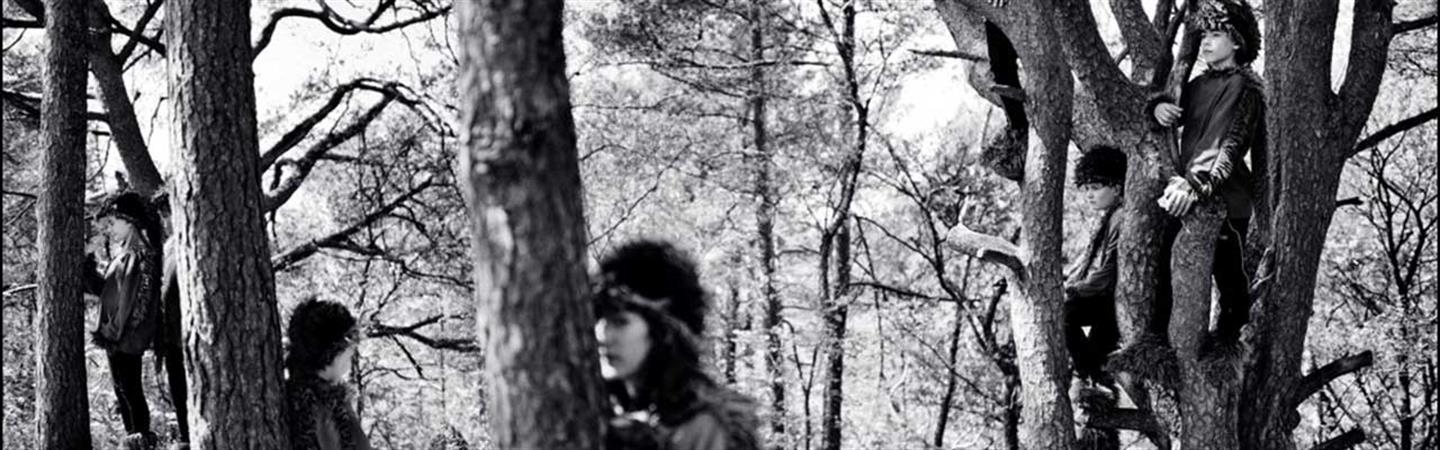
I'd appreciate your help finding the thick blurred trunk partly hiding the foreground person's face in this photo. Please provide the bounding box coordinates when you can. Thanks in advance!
[456,0,603,449]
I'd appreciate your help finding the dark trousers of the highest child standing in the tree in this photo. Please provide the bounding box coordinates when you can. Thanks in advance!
[1152,218,1250,342]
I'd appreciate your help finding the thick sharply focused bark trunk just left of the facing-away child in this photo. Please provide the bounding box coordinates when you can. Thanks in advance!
[166,0,288,449]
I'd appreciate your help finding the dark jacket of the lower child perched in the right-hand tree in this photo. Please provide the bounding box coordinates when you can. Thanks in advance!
[1066,208,1125,301]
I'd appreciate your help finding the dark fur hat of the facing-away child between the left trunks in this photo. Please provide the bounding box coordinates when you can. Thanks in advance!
[285,297,357,376]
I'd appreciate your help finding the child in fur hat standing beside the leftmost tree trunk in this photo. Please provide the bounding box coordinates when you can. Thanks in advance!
[82,192,163,449]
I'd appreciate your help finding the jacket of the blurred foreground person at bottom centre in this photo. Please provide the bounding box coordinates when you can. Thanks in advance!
[606,384,760,450]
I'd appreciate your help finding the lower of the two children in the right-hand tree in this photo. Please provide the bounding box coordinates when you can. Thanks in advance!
[1064,146,1126,385]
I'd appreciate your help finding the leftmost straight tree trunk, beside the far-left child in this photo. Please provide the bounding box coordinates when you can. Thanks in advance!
[35,0,91,449]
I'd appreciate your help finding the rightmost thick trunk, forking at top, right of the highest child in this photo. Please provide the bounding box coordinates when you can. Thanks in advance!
[1240,0,1392,449]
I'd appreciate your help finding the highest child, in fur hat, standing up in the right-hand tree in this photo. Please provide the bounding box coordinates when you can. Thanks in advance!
[1151,0,1264,343]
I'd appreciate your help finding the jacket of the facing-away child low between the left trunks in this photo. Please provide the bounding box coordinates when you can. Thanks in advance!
[285,375,370,450]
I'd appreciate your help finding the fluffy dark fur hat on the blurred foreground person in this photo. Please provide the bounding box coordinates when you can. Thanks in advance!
[592,239,710,336]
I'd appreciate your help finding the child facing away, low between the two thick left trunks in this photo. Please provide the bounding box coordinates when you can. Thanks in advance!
[285,299,370,450]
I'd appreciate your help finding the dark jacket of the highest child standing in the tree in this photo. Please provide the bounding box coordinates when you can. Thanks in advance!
[1148,68,1266,219]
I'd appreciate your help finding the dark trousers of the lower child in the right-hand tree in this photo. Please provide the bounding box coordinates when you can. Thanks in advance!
[1066,297,1120,378]
